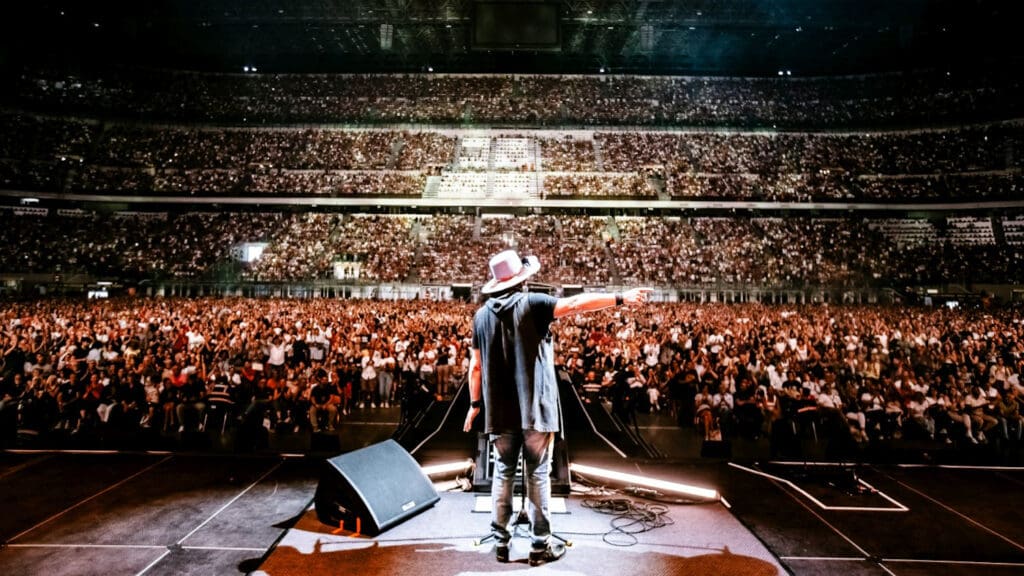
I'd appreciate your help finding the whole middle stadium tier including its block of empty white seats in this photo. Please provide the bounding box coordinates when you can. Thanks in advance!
[0,105,1024,211]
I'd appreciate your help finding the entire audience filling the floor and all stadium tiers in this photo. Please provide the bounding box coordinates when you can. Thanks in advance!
[0,70,1024,453]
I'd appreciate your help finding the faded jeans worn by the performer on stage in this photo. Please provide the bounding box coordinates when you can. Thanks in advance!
[490,430,555,549]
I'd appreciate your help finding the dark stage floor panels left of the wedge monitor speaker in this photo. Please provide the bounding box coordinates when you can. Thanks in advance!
[0,454,316,576]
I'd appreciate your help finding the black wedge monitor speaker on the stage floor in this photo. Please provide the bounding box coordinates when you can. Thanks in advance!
[313,440,440,536]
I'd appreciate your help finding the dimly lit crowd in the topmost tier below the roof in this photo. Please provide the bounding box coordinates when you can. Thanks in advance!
[4,69,1024,128]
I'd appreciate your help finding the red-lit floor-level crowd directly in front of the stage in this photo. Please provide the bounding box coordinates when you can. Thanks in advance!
[0,298,1024,453]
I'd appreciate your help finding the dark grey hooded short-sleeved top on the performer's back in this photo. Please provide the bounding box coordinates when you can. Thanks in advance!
[473,292,561,434]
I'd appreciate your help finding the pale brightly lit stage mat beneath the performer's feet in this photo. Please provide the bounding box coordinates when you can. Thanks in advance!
[257,492,784,576]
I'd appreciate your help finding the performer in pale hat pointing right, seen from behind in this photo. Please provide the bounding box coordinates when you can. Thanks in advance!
[463,250,650,566]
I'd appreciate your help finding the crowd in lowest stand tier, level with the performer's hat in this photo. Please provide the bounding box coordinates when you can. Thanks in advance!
[0,209,1024,287]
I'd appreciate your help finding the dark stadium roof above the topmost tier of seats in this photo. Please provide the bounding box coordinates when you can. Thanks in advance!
[0,0,1022,76]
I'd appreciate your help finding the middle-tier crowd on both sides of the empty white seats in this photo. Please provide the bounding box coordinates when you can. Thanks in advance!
[0,108,1024,201]
